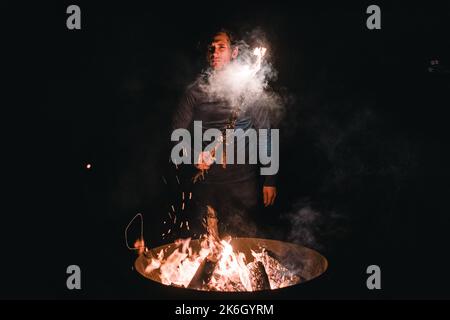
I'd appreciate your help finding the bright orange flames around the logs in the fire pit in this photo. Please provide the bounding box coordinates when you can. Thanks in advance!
[140,231,299,291]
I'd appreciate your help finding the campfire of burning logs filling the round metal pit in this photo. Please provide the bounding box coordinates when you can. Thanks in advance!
[130,206,327,291]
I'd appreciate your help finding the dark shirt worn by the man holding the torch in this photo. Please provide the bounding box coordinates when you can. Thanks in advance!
[172,79,275,186]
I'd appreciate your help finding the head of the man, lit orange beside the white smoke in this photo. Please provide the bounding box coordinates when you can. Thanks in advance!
[207,31,238,70]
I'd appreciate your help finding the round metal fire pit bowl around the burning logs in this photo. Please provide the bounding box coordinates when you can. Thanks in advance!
[135,238,328,292]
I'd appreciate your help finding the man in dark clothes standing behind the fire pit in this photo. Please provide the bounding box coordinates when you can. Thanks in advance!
[173,31,277,236]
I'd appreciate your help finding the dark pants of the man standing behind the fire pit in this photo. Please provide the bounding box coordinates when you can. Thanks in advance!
[193,179,262,237]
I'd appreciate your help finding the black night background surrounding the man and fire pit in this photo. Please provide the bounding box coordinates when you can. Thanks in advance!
[0,2,450,299]
